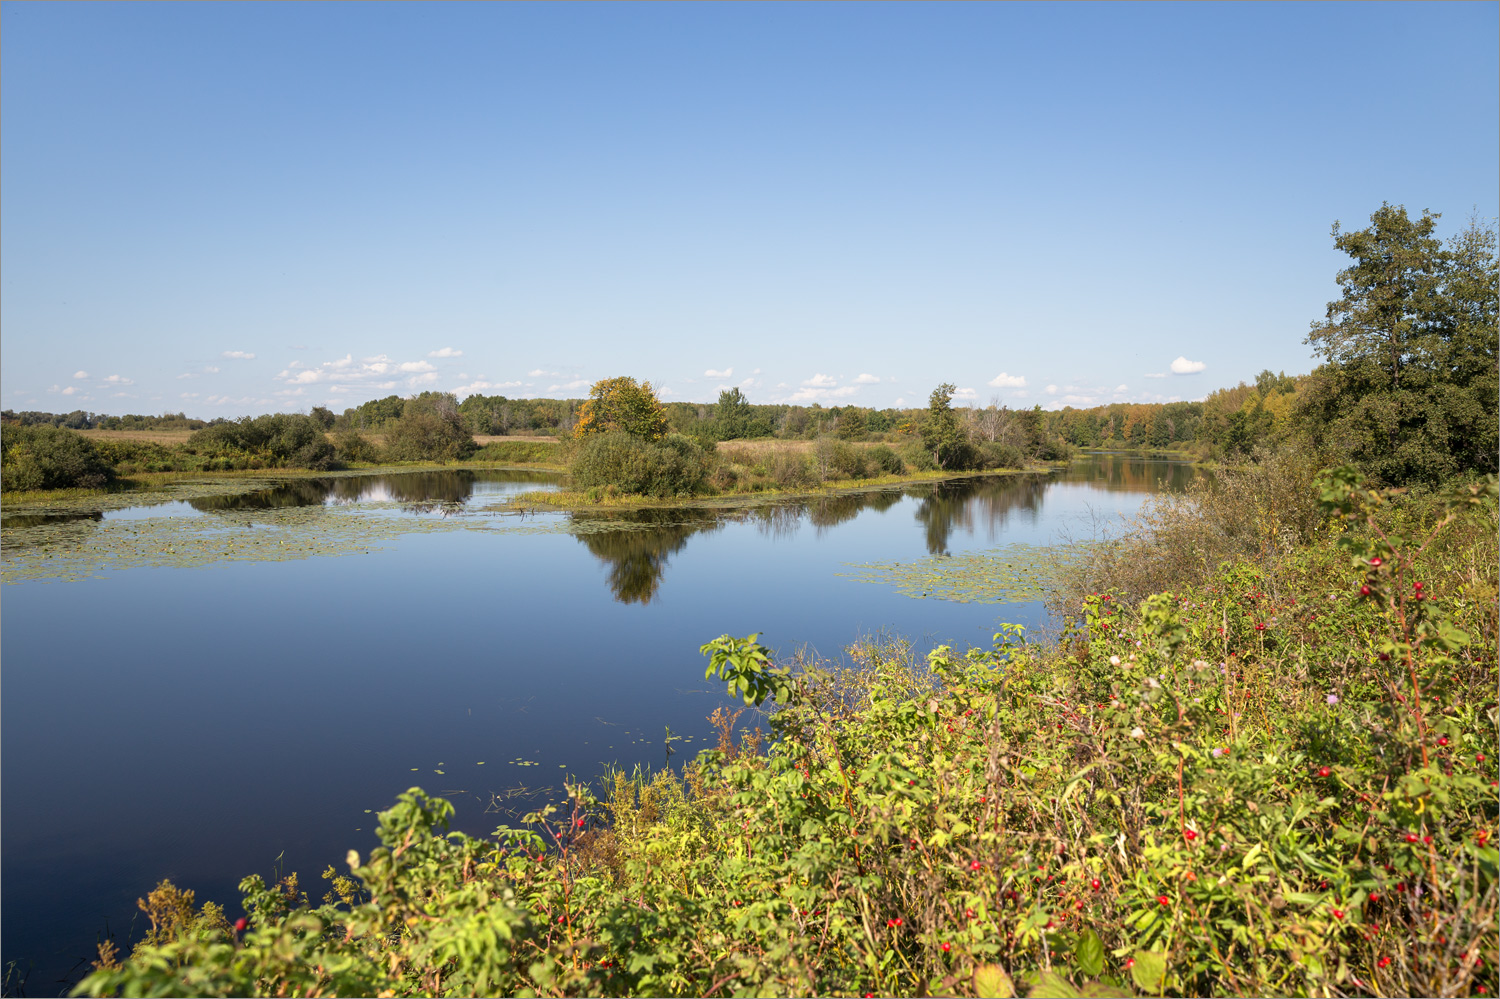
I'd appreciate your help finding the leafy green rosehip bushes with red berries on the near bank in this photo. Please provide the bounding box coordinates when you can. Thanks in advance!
[80,473,1500,996]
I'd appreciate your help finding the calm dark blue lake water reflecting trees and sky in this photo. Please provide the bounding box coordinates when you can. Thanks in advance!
[0,455,1193,995]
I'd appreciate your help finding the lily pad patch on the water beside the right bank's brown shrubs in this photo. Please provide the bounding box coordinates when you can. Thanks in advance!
[837,543,1088,603]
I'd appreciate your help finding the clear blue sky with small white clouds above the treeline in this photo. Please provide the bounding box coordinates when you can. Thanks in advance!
[0,2,1500,417]
